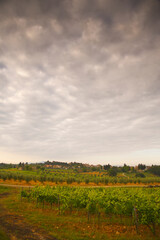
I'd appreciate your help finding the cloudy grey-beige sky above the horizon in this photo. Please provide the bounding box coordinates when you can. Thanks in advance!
[0,0,160,165]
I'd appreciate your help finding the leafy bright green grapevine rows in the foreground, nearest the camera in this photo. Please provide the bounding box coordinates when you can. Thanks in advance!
[21,186,160,234]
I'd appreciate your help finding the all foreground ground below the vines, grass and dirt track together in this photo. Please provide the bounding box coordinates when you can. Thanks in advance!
[0,187,160,240]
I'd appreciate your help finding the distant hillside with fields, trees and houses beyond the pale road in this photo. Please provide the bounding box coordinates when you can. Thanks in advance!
[0,161,160,186]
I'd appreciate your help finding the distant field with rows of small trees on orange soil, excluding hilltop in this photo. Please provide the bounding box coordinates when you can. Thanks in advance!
[0,168,160,186]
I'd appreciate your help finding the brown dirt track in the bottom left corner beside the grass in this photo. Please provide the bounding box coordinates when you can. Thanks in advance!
[0,193,57,240]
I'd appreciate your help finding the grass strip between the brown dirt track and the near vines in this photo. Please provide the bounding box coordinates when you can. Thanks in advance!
[0,187,160,240]
